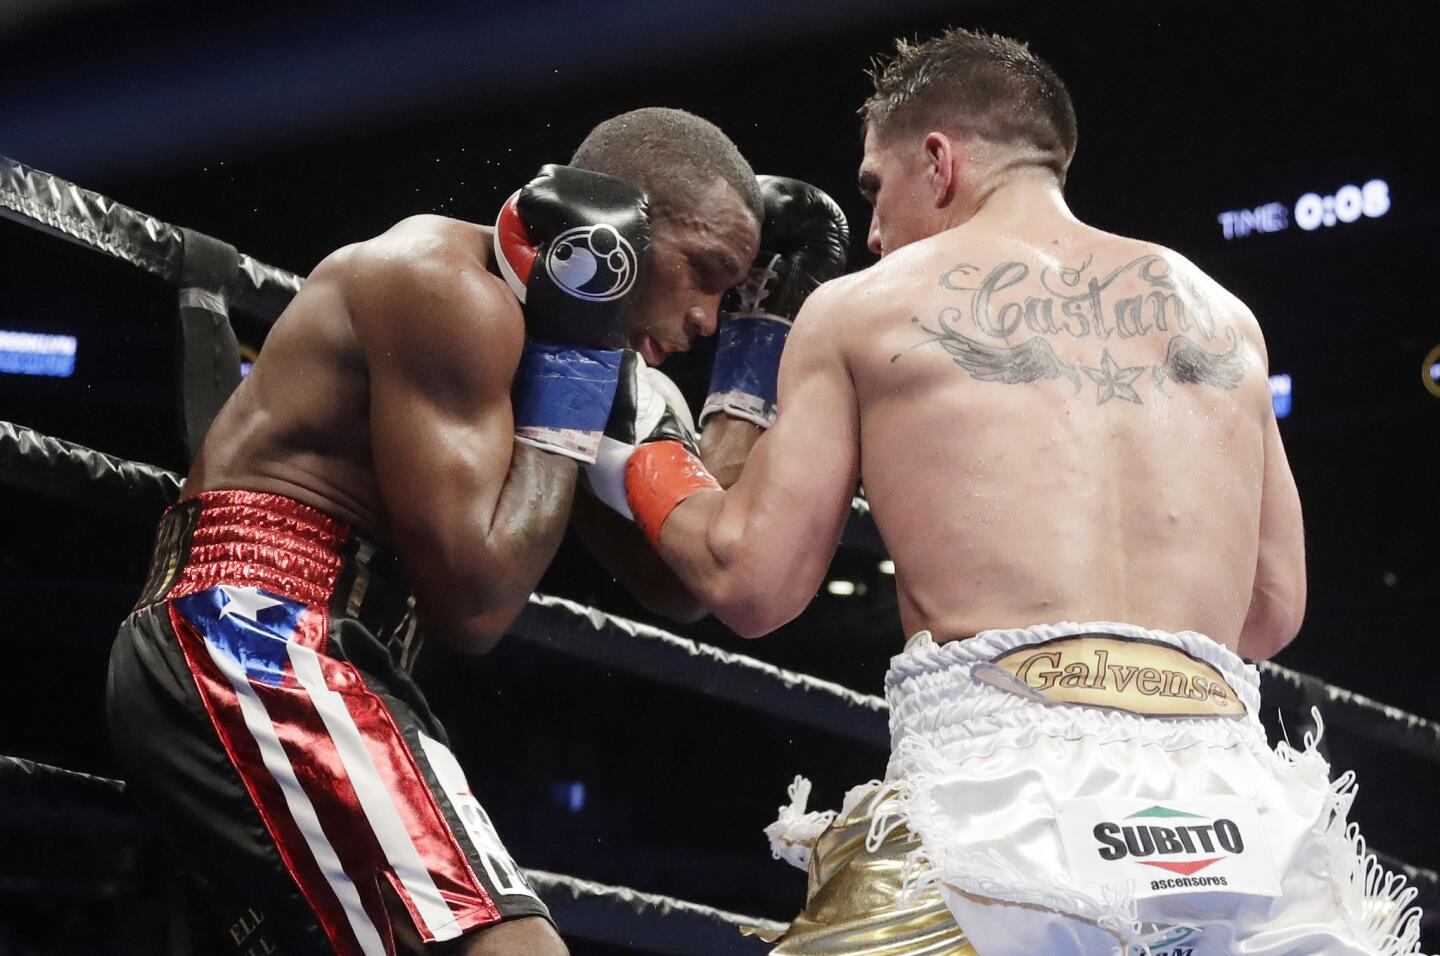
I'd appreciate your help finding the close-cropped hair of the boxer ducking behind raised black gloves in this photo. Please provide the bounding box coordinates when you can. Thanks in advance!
[570,107,765,222]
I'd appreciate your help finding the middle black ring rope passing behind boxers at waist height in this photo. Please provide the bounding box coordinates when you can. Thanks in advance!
[0,422,1440,763]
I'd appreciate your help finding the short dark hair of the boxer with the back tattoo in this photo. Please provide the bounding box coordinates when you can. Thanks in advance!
[860,27,1077,181]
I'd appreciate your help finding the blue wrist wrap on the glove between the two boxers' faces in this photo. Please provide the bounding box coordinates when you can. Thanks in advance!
[700,315,791,428]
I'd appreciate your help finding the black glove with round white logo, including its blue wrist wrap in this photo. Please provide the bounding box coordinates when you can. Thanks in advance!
[495,166,649,462]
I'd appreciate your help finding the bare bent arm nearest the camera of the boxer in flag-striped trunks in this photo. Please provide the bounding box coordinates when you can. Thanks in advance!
[347,227,577,652]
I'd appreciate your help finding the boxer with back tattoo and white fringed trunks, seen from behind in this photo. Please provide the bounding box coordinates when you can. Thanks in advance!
[592,30,1418,956]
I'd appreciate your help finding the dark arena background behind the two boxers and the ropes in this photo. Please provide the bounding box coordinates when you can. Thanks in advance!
[0,0,1440,955]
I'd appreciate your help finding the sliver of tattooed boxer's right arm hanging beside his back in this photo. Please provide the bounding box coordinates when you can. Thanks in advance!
[1240,415,1306,659]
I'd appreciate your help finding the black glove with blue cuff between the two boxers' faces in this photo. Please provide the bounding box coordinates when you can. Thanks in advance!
[700,176,850,428]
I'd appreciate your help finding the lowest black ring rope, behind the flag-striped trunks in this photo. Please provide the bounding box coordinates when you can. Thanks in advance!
[0,754,785,956]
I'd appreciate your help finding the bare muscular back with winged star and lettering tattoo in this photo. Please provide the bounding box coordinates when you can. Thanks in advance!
[841,222,1273,648]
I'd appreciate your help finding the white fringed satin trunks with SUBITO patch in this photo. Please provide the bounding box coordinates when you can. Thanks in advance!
[769,623,1420,956]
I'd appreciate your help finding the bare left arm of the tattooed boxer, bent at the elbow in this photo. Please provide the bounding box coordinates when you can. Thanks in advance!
[660,288,860,636]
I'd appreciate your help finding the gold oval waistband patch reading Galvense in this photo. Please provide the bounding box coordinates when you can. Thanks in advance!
[973,633,1246,717]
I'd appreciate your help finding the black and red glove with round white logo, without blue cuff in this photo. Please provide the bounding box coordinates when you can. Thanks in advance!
[495,164,649,350]
